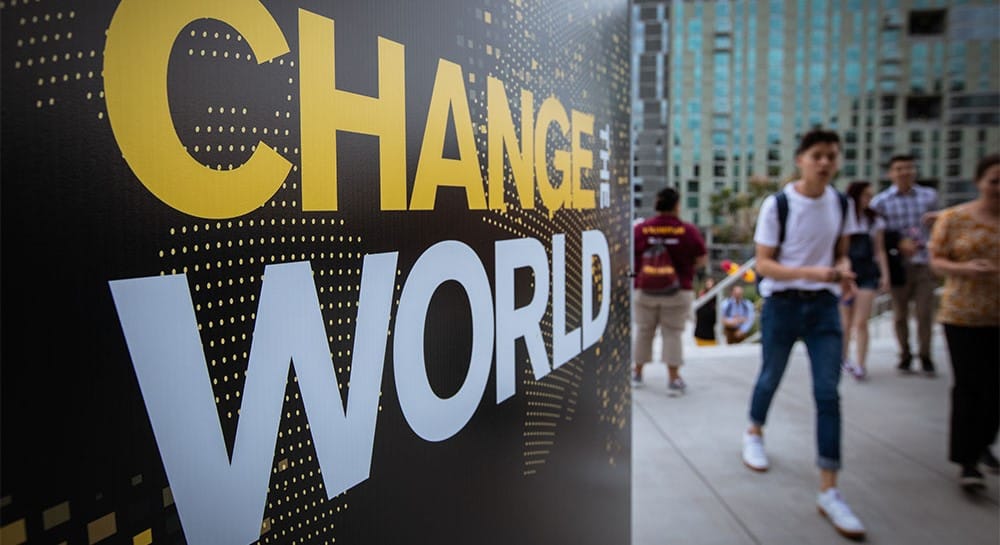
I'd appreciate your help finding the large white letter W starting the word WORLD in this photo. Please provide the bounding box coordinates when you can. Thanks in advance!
[110,253,397,545]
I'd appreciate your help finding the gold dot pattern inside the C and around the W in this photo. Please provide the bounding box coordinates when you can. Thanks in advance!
[158,21,381,545]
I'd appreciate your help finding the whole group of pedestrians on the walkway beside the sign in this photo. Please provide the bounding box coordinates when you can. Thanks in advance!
[632,129,1000,539]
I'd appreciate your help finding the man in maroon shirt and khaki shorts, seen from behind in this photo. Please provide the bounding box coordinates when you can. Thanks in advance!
[632,187,707,395]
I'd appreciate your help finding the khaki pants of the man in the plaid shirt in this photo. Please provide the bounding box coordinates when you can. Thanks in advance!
[892,263,937,358]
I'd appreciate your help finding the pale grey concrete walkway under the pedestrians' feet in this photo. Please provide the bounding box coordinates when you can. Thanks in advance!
[632,316,1000,545]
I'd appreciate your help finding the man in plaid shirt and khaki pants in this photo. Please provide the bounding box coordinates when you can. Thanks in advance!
[870,155,938,376]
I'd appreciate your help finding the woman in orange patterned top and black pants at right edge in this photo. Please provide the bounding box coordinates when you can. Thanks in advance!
[930,154,1000,491]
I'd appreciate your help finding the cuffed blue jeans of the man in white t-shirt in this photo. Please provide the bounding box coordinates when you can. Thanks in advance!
[750,292,843,471]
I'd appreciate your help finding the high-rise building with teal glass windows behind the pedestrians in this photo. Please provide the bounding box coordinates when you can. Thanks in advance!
[632,0,1000,226]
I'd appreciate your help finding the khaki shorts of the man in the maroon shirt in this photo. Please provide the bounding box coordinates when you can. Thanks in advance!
[632,290,694,367]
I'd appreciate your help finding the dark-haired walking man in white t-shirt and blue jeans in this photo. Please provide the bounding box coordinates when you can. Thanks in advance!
[743,129,865,538]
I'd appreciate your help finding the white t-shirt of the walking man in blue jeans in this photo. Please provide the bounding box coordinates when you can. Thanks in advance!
[753,183,857,297]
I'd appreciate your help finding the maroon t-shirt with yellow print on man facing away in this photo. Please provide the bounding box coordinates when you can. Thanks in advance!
[632,214,706,290]
